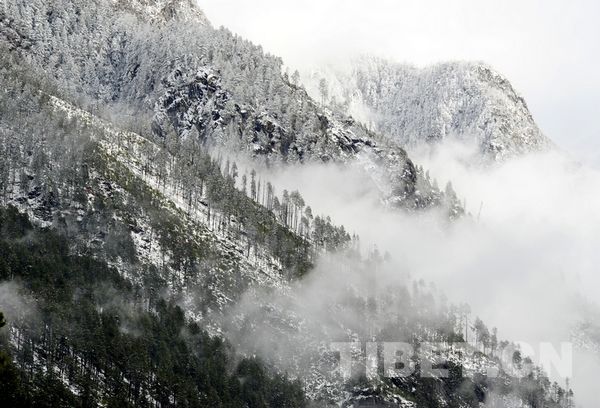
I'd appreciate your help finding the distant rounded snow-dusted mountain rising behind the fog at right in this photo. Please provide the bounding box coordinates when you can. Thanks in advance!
[306,57,551,160]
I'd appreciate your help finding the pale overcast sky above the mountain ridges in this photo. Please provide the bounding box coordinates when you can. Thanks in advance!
[198,0,600,167]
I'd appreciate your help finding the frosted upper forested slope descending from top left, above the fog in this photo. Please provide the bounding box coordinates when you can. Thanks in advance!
[0,0,462,216]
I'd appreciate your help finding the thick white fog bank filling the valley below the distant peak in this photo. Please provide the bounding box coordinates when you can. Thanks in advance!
[231,141,600,407]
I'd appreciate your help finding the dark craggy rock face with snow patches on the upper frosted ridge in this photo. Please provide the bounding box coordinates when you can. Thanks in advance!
[153,67,454,214]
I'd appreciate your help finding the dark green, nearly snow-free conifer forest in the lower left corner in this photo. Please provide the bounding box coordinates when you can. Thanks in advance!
[0,208,305,407]
